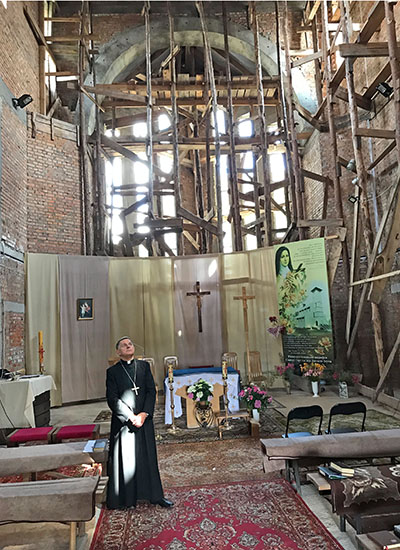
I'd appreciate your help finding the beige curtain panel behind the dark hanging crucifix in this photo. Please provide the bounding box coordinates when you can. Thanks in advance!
[174,255,223,368]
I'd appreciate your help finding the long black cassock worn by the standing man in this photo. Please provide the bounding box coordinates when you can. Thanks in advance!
[106,359,163,508]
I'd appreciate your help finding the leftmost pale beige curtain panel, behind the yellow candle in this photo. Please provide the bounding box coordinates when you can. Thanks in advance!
[25,254,62,406]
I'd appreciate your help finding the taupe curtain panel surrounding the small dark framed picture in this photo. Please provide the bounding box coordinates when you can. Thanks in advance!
[59,256,110,403]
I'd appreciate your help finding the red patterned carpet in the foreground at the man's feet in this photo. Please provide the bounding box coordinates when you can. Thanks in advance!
[90,479,342,550]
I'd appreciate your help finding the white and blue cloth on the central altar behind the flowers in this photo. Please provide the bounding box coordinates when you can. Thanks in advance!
[164,367,239,424]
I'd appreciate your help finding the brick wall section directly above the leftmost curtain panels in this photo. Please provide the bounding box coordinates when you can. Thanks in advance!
[26,116,82,254]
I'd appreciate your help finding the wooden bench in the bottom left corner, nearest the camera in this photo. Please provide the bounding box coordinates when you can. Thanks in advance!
[0,476,107,550]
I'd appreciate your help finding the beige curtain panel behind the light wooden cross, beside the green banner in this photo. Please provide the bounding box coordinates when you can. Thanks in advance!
[221,248,282,382]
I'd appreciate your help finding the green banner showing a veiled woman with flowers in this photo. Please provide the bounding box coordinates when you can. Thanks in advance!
[270,239,333,365]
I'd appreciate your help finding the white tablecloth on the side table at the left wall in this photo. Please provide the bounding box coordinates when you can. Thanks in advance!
[0,375,56,428]
